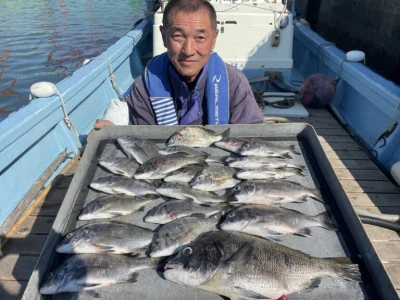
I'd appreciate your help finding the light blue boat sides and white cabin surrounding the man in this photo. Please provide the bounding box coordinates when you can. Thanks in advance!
[0,0,400,299]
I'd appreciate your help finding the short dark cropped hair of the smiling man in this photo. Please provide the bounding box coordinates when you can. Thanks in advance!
[163,0,217,30]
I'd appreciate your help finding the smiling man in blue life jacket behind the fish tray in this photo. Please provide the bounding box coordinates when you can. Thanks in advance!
[95,0,264,129]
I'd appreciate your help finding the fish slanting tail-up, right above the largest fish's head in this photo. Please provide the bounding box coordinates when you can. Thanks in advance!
[150,213,221,257]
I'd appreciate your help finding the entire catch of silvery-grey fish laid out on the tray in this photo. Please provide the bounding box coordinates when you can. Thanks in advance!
[41,126,361,299]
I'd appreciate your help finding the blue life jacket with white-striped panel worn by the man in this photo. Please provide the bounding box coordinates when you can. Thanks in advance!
[144,52,229,125]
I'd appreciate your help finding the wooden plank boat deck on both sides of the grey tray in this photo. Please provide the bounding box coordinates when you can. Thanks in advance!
[0,110,400,299]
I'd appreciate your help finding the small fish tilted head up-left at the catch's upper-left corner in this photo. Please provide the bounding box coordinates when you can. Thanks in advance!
[117,136,160,164]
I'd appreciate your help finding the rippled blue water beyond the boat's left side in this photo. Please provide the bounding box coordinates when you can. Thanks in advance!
[0,0,145,121]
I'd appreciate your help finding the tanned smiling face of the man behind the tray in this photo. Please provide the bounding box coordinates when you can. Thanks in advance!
[160,9,218,82]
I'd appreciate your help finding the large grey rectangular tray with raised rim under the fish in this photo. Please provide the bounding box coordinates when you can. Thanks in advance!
[23,123,397,300]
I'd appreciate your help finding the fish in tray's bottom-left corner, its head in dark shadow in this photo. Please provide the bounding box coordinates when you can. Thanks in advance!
[40,254,158,295]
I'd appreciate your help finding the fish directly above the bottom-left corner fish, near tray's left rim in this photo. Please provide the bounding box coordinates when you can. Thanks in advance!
[56,221,153,254]
